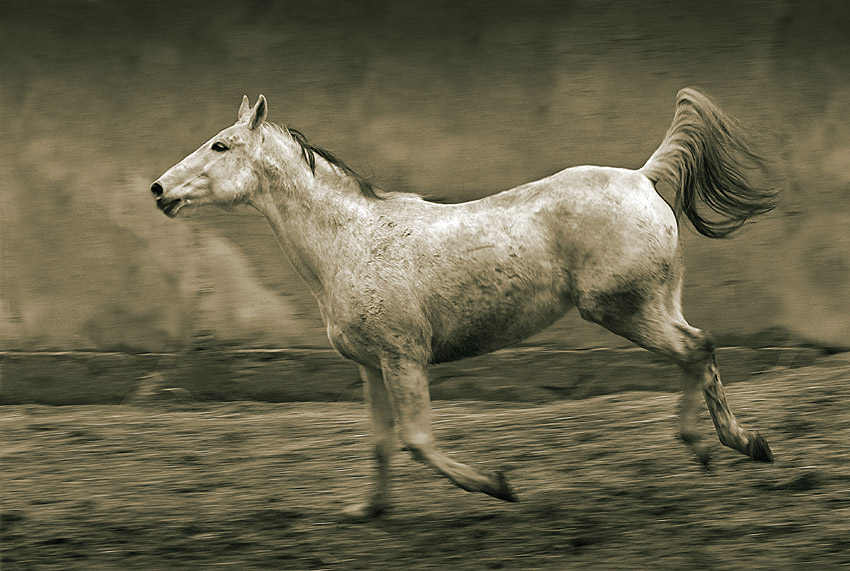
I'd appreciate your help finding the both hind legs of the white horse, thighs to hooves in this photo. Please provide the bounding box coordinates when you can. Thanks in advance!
[579,279,773,464]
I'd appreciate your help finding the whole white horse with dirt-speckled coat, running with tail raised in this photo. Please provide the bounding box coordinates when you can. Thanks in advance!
[151,89,776,517]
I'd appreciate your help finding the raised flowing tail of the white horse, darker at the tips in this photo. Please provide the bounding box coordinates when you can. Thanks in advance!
[638,88,778,238]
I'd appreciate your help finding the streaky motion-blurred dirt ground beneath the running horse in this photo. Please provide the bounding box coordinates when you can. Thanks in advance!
[0,355,850,571]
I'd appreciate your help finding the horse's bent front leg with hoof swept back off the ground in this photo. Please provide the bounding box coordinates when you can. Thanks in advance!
[383,362,517,502]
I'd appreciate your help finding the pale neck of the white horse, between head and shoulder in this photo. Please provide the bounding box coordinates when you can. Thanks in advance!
[251,135,369,296]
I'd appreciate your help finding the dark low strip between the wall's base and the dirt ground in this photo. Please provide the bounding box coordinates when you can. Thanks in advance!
[0,346,829,405]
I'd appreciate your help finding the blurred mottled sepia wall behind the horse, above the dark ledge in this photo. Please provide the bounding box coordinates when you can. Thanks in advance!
[0,0,850,351]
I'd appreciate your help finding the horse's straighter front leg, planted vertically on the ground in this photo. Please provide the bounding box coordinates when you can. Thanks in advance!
[345,365,396,520]
